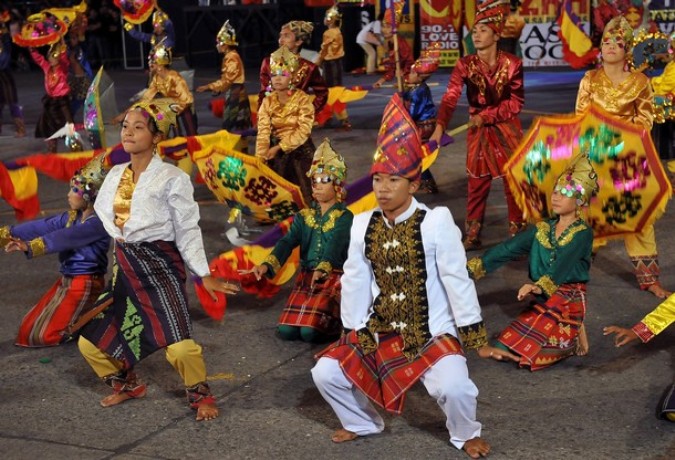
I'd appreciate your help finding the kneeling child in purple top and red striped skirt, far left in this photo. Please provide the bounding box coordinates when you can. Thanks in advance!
[0,155,110,347]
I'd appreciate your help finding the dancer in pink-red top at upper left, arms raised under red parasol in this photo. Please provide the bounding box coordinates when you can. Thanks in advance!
[30,42,73,153]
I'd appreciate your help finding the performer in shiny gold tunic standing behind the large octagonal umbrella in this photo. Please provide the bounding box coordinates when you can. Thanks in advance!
[576,17,670,299]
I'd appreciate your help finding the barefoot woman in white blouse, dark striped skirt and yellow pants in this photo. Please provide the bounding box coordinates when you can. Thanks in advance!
[78,99,237,420]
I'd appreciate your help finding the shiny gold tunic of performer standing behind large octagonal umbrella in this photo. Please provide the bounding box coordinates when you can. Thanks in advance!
[576,69,654,129]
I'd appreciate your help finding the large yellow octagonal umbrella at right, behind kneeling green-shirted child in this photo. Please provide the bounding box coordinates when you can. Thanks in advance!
[505,106,672,238]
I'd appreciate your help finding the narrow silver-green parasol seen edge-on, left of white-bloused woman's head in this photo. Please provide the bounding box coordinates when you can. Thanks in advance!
[83,67,118,149]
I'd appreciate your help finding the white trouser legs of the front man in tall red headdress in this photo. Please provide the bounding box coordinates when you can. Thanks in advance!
[312,355,481,449]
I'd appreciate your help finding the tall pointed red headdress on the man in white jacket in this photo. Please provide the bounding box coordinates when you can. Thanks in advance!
[370,93,422,180]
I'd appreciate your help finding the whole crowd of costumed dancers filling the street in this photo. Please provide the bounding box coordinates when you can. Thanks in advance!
[0,1,675,458]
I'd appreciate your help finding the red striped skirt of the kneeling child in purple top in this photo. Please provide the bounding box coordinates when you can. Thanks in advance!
[15,275,104,347]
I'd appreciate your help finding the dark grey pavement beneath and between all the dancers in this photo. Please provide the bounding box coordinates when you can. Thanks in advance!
[0,65,675,460]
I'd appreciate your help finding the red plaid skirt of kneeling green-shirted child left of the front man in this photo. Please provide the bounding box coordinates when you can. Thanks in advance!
[279,270,342,335]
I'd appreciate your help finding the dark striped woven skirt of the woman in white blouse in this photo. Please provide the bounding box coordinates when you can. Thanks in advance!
[82,241,192,369]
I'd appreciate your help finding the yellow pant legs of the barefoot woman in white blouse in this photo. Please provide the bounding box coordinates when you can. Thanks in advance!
[77,336,206,387]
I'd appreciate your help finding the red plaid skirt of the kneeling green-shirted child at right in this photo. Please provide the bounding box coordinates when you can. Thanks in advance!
[498,283,586,371]
